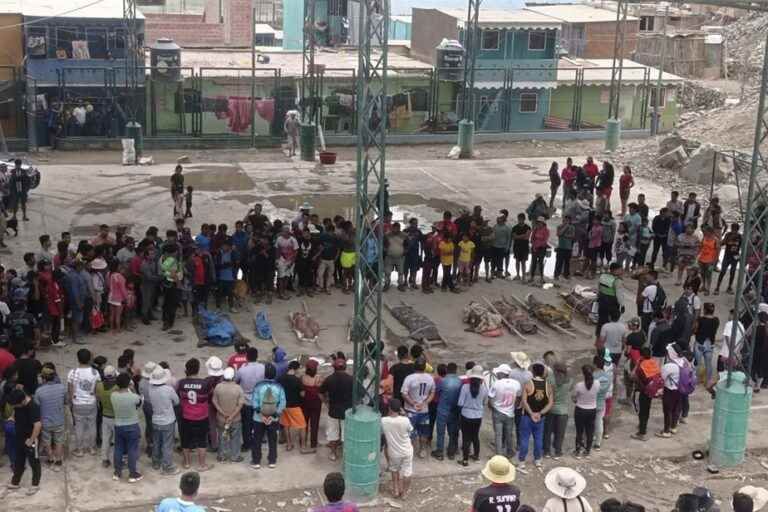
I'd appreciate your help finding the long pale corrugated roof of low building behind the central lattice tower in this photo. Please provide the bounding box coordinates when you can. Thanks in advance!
[181,47,432,77]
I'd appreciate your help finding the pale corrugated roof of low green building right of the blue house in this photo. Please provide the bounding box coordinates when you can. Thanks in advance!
[557,58,684,85]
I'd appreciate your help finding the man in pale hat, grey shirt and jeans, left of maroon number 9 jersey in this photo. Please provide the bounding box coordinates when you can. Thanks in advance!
[149,365,179,475]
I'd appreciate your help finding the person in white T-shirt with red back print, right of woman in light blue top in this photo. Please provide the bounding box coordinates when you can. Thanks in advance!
[488,364,522,459]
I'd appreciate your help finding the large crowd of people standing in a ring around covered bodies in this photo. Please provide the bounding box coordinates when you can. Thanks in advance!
[0,158,768,512]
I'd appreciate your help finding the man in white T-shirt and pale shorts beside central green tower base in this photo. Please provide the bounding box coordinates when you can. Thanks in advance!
[381,398,414,498]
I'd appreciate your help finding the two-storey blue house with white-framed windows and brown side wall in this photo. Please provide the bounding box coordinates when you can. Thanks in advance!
[411,8,562,131]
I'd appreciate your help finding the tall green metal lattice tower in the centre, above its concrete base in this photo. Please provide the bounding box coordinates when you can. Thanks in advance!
[352,0,389,409]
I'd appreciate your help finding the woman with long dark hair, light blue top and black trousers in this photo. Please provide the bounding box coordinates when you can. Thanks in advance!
[458,366,488,466]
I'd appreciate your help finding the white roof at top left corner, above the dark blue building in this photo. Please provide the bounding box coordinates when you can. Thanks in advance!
[0,0,144,19]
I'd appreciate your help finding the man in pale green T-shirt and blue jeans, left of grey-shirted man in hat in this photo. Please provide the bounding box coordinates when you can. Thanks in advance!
[111,373,144,484]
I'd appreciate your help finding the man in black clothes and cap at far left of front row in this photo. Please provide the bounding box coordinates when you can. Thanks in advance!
[6,389,43,496]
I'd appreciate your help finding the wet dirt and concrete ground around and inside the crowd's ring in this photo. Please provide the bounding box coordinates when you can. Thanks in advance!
[0,143,768,512]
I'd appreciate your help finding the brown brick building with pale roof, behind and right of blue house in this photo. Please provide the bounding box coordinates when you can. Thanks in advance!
[526,4,640,59]
